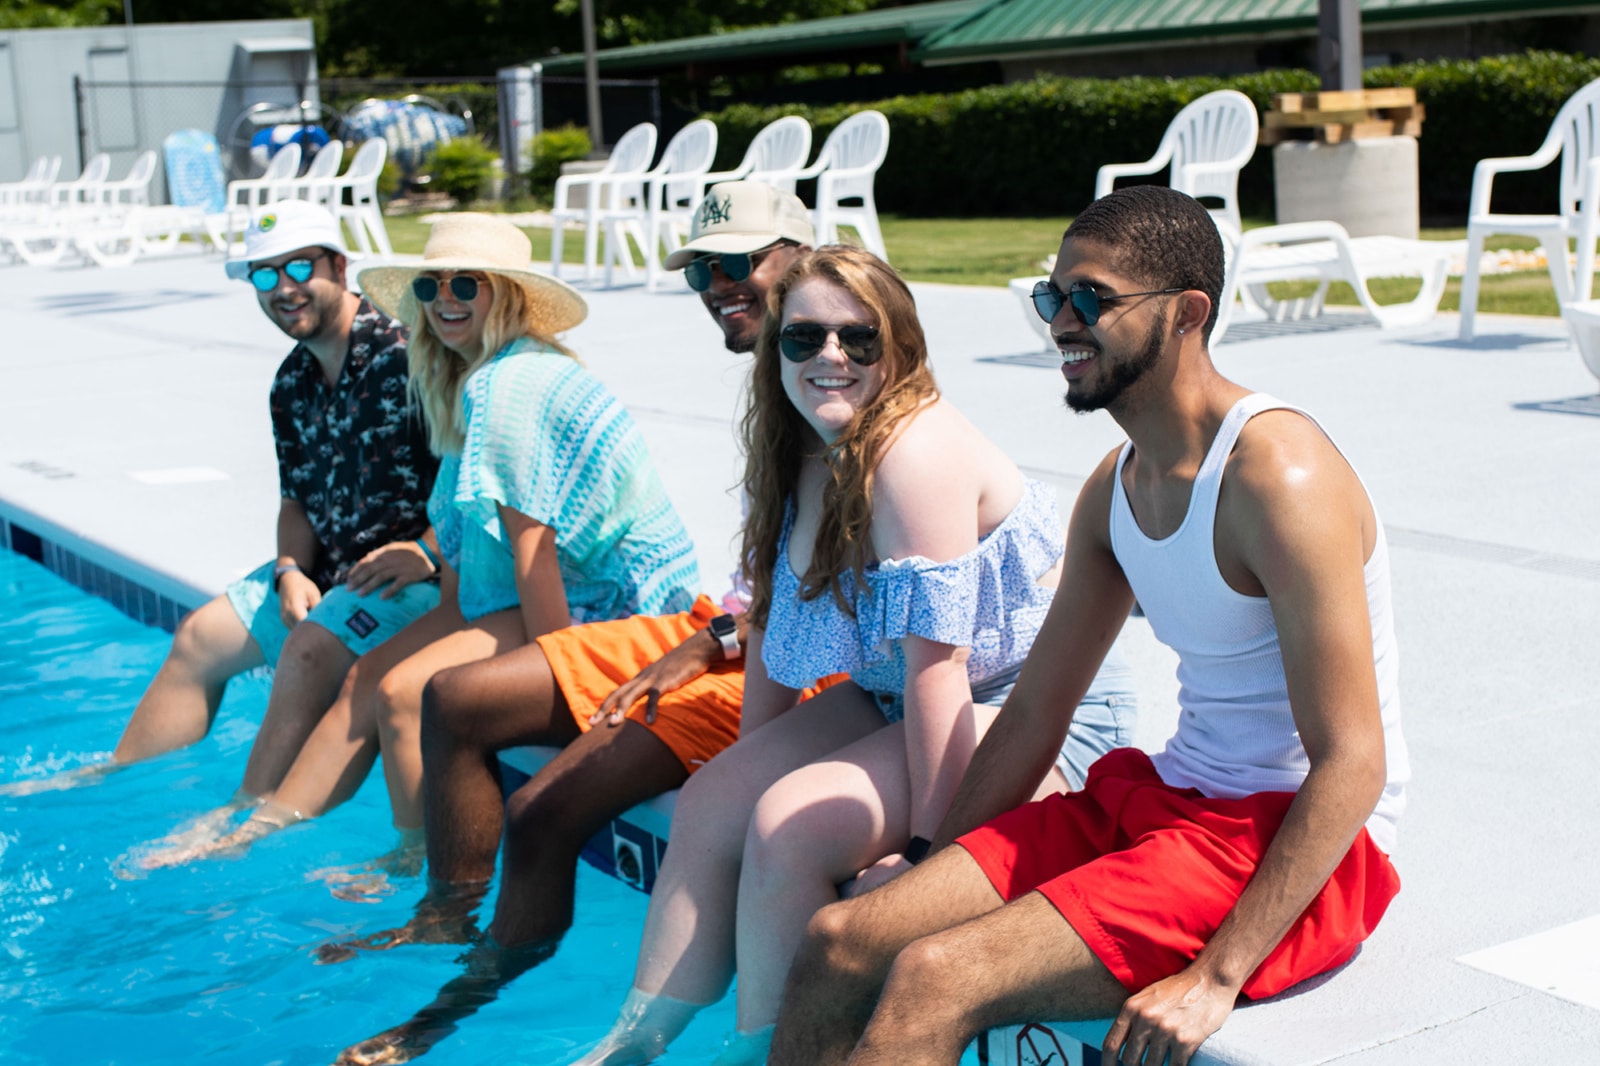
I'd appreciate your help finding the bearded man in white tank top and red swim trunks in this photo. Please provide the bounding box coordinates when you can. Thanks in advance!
[770,186,1410,1066]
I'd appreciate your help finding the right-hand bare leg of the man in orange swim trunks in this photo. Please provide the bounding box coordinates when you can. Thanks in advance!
[339,722,686,1063]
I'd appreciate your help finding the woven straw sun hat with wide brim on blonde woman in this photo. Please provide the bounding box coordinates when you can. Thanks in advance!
[357,214,589,336]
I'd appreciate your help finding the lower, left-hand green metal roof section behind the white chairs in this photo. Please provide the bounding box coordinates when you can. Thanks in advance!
[539,0,985,74]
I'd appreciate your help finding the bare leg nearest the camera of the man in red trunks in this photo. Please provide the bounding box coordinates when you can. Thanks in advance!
[848,892,1128,1066]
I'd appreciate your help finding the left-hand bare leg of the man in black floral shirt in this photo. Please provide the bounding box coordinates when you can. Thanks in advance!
[112,595,264,763]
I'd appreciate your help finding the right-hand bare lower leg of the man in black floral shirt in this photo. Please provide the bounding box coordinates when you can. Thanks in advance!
[242,623,355,797]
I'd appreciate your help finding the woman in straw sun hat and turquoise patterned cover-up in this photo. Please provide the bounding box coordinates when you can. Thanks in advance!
[200,214,699,866]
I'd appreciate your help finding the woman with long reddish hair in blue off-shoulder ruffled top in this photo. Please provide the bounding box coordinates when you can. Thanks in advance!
[582,246,1133,1066]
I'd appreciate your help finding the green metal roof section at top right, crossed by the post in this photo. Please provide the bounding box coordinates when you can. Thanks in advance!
[910,0,1600,64]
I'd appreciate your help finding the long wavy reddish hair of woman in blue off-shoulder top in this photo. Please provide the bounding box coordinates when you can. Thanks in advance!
[739,245,939,626]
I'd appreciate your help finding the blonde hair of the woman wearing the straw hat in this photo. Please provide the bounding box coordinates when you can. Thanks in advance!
[406,271,578,455]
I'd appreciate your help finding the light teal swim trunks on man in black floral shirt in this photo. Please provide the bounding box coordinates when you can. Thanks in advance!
[227,560,438,666]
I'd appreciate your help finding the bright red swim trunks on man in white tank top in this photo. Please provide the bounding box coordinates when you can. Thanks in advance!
[957,747,1400,999]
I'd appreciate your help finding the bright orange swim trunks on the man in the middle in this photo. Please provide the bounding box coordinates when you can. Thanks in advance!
[538,595,834,773]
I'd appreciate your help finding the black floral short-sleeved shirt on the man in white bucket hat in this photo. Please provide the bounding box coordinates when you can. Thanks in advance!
[272,298,438,591]
